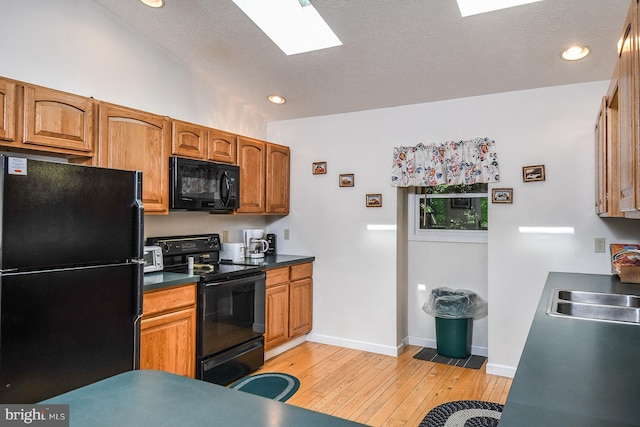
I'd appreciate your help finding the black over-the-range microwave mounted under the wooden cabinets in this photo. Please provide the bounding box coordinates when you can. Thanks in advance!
[169,156,240,212]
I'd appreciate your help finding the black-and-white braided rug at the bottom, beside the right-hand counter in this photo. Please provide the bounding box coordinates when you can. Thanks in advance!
[419,400,503,427]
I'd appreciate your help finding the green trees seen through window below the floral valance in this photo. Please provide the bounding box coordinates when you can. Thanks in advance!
[418,184,489,230]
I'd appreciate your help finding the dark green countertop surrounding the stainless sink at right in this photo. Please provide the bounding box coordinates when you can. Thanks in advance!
[500,273,640,427]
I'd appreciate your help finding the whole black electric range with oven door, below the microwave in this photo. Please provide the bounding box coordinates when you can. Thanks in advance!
[147,234,266,385]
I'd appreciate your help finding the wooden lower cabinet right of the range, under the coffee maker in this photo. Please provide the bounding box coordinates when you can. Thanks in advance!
[264,262,313,350]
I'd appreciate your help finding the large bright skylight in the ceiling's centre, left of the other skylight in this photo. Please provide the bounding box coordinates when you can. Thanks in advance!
[233,0,342,55]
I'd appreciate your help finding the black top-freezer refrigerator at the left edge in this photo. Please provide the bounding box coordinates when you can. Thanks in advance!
[0,155,144,404]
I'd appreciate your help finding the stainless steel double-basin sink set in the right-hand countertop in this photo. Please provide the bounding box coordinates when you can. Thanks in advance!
[547,289,640,323]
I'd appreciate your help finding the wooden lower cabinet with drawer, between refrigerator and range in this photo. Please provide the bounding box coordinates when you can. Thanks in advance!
[140,283,196,378]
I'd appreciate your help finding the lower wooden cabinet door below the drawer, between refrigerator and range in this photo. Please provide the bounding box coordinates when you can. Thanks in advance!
[140,307,196,378]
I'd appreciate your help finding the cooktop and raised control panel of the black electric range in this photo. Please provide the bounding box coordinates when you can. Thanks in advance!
[147,234,264,282]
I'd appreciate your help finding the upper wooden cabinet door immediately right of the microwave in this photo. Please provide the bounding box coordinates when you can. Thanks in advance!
[237,137,266,213]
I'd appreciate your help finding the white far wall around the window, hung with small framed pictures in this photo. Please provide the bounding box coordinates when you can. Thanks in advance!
[267,82,640,375]
